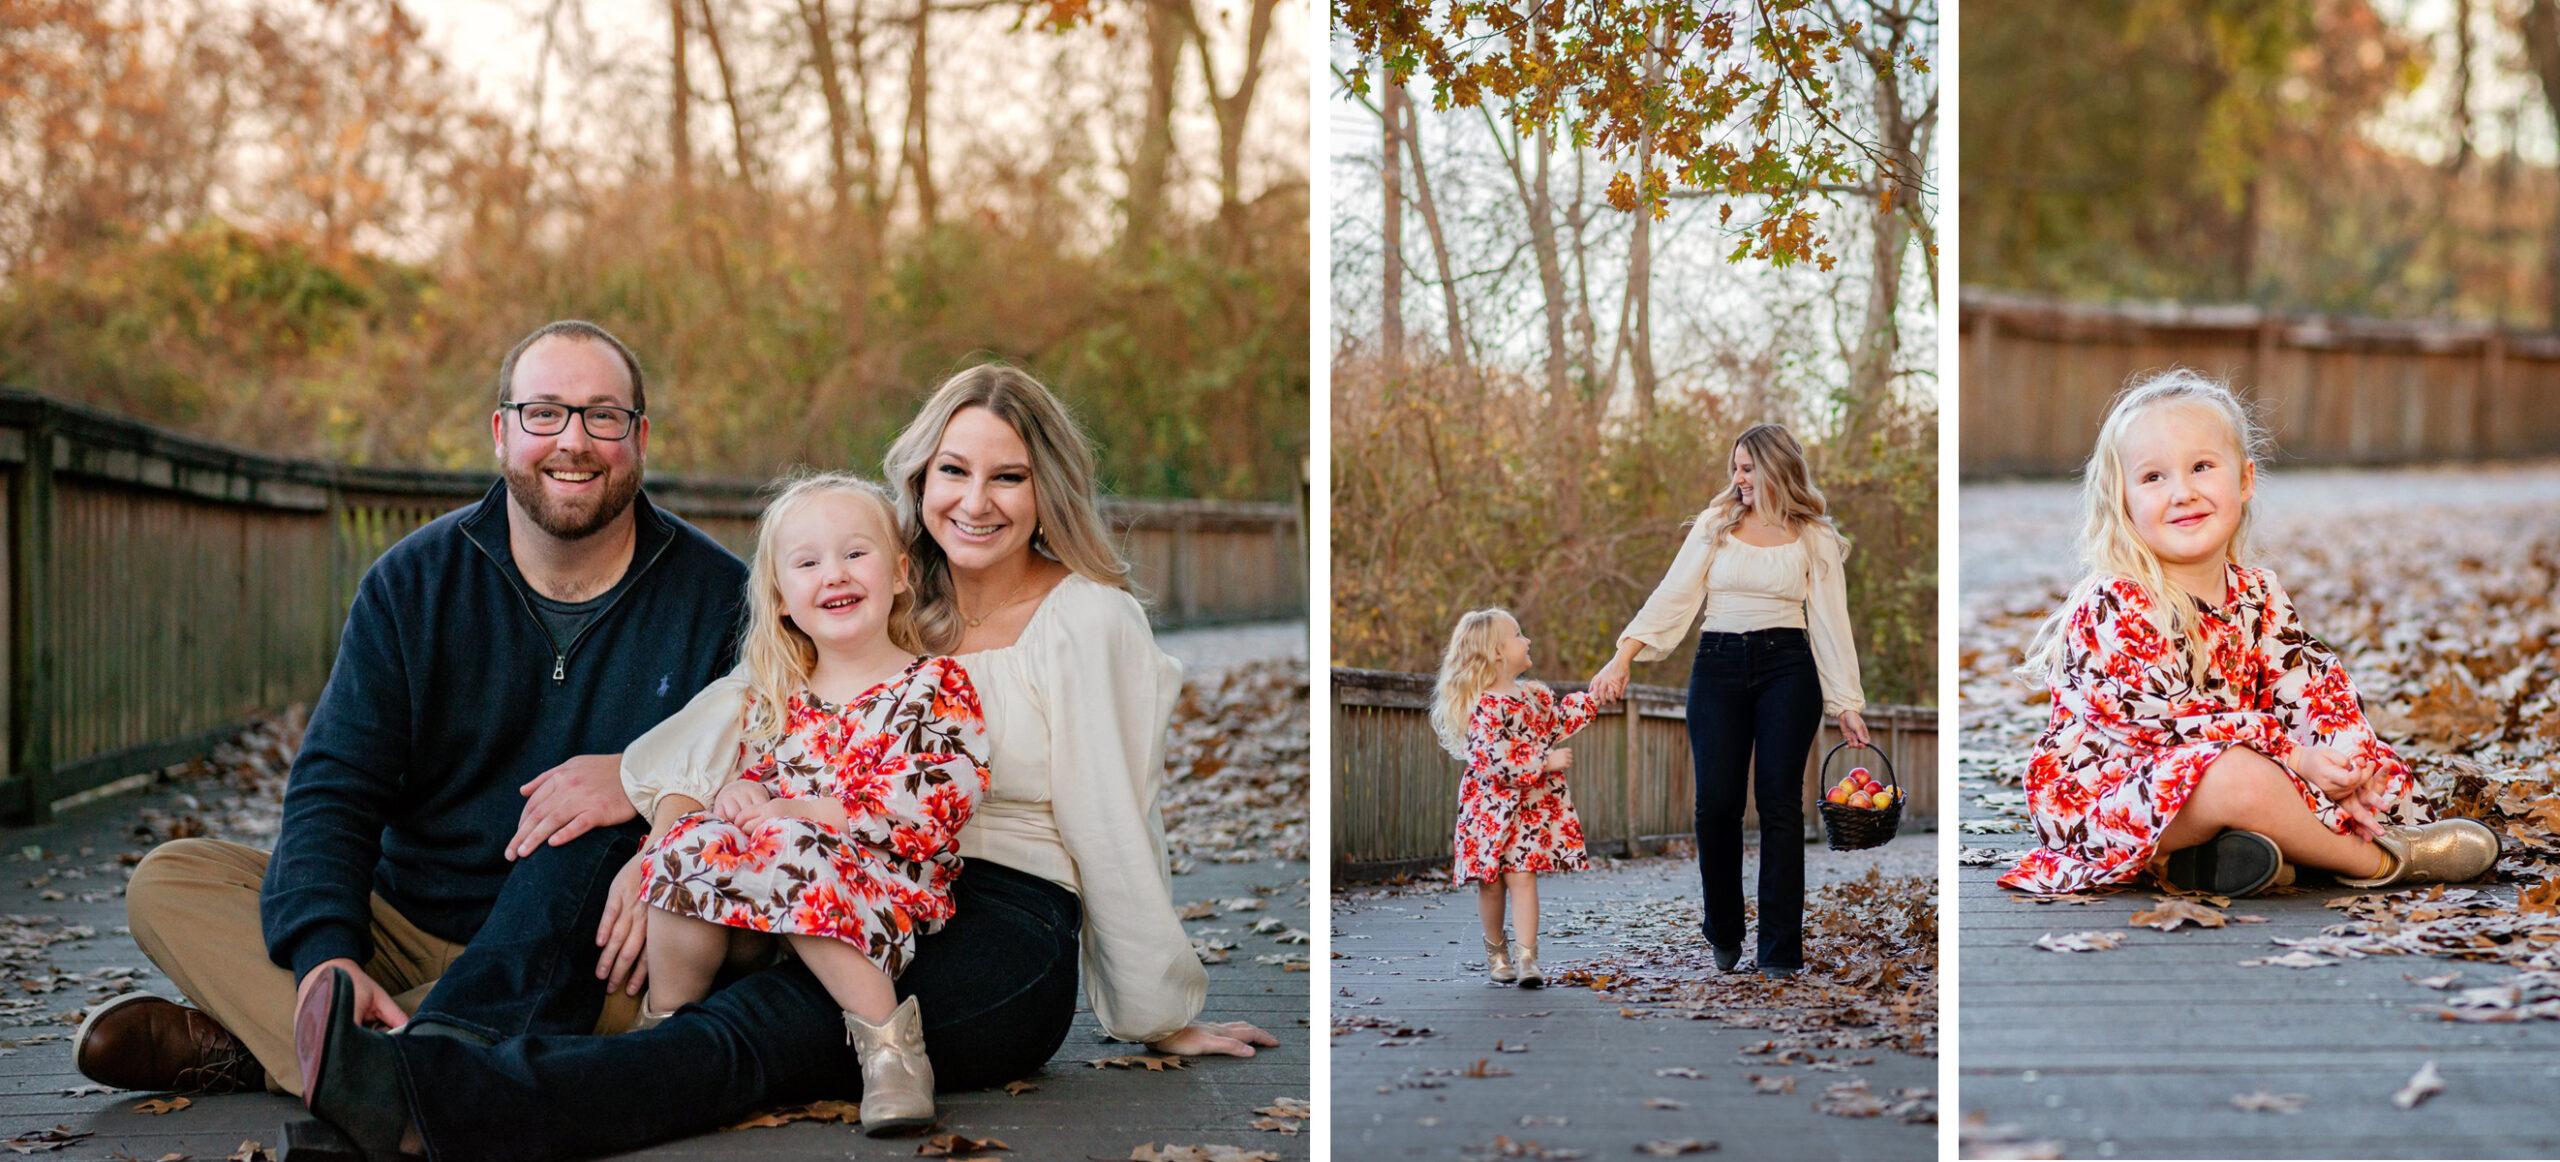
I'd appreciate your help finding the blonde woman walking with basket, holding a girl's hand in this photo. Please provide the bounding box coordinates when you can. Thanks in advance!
[1592,425,1866,978]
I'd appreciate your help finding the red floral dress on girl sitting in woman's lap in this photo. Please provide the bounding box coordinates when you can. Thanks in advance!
[645,658,988,978]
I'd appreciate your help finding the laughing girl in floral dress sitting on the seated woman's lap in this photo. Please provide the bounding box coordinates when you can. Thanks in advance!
[625,474,988,1134]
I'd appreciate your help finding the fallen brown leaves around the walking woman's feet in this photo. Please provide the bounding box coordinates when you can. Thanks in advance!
[1562,870,1938,1055]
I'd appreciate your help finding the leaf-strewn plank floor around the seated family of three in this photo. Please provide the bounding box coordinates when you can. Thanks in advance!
[0,622,1313,1162]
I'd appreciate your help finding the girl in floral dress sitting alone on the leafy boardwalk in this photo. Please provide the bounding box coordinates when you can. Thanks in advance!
[1999,371,2499,896]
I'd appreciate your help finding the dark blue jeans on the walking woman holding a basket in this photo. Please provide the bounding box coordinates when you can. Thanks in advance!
[1690,630,1823,967]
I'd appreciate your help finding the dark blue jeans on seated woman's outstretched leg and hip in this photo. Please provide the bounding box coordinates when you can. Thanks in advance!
[392,860,1083,1162]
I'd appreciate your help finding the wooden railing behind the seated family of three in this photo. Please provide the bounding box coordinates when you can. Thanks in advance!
[0,389,1306,822]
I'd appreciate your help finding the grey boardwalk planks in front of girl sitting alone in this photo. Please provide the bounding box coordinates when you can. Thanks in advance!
[1956,776,2560,1157]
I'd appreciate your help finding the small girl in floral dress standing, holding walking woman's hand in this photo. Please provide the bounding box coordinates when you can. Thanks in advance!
[1431,609,1597,988]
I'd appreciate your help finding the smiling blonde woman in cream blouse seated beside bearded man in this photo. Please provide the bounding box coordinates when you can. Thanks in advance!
[293,366,1280,1159]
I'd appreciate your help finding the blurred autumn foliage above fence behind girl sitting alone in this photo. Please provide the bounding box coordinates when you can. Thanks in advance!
[1958,0,2560,328]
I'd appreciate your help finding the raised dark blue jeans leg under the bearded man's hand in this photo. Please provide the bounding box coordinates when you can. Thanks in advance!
[410,824,648,1042]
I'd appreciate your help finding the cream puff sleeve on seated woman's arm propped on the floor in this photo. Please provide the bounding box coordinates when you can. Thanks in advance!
[1039,578,1208,1042]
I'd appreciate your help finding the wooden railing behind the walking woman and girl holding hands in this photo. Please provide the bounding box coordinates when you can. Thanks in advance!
[1331,665,1938,880]
